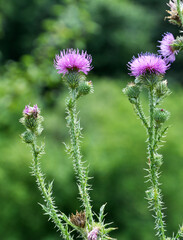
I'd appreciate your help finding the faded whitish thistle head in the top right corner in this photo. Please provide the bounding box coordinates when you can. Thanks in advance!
[165,0,183,26]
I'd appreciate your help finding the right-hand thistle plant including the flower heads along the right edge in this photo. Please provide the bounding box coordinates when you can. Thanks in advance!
[123,0,183,240]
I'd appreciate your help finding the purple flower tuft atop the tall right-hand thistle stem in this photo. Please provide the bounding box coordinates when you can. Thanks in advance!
[127,52,170,77]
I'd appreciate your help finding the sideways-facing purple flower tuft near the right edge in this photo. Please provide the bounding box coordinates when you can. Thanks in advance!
[158,32,178,63]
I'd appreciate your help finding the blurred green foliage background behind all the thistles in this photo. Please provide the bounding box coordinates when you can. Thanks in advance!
[0,0,183,240]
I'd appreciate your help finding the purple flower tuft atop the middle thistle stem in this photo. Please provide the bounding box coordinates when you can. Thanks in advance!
[54,49,93,75]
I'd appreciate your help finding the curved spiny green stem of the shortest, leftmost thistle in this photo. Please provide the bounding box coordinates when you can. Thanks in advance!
[32,140,73,240]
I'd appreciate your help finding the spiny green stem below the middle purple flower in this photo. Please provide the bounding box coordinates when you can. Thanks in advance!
[67,89,93,224]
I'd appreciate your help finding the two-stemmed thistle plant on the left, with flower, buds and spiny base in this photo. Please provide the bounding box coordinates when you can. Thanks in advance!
[20,49,114,240]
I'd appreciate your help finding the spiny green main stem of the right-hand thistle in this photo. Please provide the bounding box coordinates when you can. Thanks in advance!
[148,87,166,240]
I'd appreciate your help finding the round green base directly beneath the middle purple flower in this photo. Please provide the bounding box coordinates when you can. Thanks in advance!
[63,71,83,89]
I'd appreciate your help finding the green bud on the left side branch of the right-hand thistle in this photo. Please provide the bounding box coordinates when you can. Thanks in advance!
[123,83,140,103]
